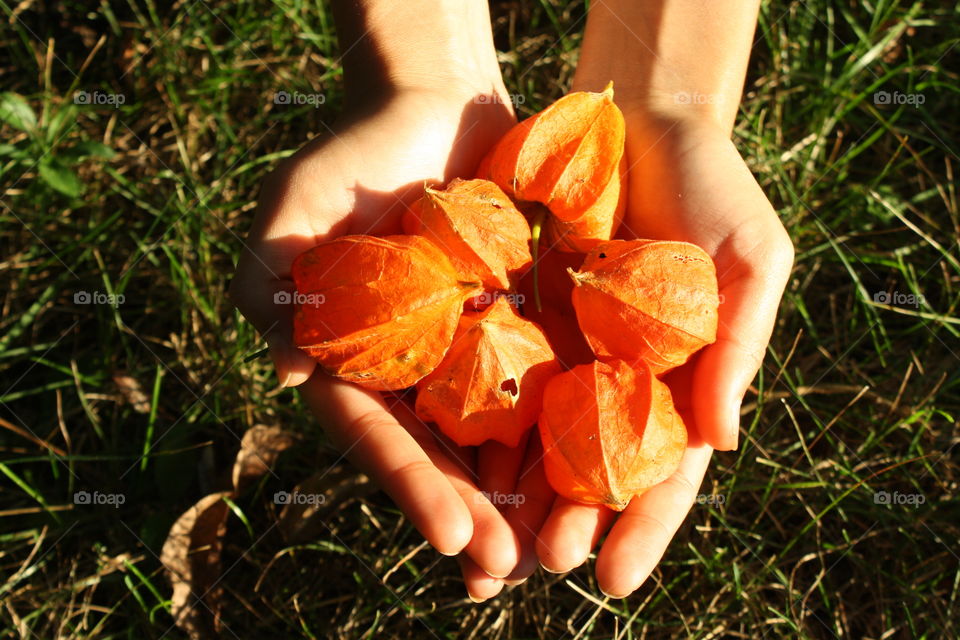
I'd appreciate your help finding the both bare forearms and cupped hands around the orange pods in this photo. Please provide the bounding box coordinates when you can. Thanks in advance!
[230,0,793,601]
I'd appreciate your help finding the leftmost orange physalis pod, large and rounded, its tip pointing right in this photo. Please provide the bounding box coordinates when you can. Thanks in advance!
[291,235,483,390]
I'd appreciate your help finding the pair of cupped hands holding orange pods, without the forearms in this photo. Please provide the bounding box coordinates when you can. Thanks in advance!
[232,95,792,598]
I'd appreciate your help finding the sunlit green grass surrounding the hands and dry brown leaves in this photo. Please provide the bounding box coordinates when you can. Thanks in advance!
[0,0,960,639]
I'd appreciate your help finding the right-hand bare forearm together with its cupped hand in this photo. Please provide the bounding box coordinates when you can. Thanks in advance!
[537,0,793,597]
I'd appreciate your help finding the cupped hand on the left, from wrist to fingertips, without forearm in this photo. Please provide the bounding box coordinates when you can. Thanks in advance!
[230,83,522,599]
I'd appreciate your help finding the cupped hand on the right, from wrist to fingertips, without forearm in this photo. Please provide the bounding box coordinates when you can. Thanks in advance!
[537,112,793,597]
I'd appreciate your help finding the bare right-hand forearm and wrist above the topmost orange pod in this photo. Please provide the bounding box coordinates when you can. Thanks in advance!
[574,0,759,137]
